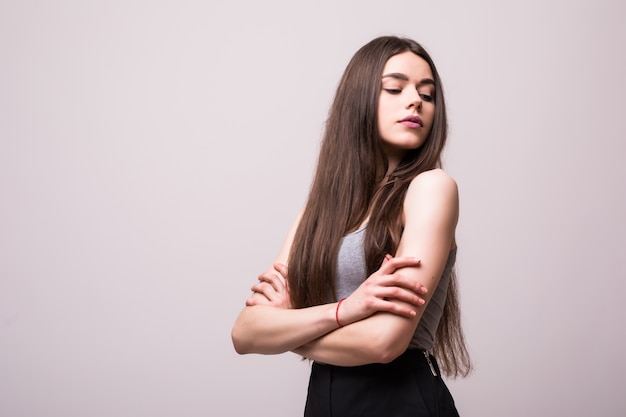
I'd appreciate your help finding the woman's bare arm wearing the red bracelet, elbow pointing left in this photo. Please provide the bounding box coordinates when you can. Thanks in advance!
[231,210,424,354]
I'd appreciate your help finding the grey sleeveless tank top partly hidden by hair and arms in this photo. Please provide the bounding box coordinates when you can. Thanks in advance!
[335,226,456,351]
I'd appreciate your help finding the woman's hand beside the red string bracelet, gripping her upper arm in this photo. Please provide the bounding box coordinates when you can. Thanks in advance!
[338,255,428,325]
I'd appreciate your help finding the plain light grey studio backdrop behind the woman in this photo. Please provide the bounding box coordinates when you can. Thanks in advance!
[0,0,626,417]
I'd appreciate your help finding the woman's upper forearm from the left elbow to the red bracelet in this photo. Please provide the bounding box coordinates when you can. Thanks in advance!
[231,303,338,354]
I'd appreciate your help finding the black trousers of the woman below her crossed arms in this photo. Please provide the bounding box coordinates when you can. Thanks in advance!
[304,349,459,417]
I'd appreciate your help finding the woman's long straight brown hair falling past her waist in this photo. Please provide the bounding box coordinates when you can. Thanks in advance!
[288,36,471,376]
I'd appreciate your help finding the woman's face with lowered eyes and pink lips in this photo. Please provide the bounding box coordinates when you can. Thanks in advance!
[378,52,435,164]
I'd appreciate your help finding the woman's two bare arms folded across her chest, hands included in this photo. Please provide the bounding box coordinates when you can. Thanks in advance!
[232,169,459,366]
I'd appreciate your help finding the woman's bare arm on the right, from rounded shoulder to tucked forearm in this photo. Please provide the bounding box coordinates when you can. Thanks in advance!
[294,170,458,366]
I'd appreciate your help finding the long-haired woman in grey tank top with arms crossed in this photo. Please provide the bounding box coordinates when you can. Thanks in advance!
[232,36,471,417]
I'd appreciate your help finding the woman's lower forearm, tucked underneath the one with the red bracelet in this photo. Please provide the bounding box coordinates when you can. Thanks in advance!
[293,313,417,366]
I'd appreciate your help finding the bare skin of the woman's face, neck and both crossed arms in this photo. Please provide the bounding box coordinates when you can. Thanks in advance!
[232,52,459,366]
